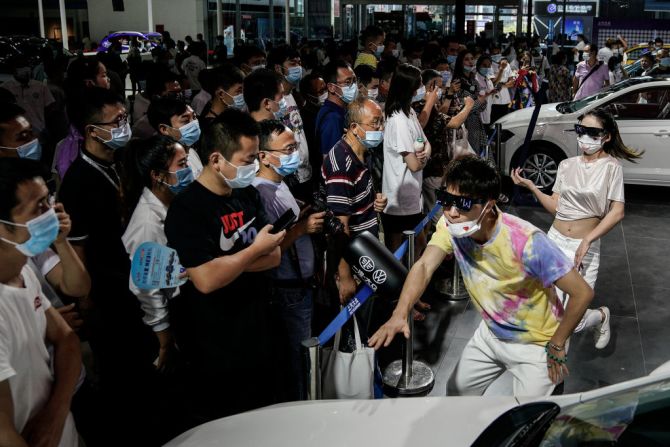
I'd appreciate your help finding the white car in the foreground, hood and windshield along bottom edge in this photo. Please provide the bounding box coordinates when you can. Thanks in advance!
[165,362,670,447]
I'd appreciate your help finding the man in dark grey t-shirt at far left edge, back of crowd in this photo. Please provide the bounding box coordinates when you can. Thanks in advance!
[2,56,55,142]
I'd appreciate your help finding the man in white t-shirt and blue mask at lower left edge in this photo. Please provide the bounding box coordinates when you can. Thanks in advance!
[0,158,81,447]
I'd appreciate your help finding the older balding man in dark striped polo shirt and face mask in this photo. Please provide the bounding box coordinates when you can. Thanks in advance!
[321,98,387,304]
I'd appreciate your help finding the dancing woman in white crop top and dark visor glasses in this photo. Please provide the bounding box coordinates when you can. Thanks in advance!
[512,109,641,349]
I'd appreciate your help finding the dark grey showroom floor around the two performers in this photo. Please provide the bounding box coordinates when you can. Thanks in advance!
[415,186,670,396]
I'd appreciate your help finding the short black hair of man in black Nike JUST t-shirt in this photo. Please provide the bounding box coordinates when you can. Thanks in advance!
[198,108,259,163]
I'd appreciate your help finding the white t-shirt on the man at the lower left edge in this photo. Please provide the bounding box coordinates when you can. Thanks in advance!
[0,264,78,447]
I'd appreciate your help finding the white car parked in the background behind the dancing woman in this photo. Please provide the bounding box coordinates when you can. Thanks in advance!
[497,77,670,191]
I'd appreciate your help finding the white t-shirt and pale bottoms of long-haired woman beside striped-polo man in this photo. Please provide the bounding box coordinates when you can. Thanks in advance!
[382,109,428,216]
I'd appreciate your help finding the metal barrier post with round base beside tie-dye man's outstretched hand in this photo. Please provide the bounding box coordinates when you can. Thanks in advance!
[383,230,435,396]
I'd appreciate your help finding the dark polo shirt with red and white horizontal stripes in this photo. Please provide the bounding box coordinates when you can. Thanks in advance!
[321,138,379,236]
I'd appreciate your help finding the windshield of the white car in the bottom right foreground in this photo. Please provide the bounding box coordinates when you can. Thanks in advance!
[532,380,670,447]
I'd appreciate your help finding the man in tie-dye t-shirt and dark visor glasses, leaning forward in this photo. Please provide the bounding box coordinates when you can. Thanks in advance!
[369,157,593,396]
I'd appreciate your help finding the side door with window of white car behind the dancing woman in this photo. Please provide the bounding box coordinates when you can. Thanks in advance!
[605,85,670,186]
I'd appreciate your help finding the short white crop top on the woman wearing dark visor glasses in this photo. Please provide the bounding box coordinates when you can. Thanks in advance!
[553,155,624,221]
